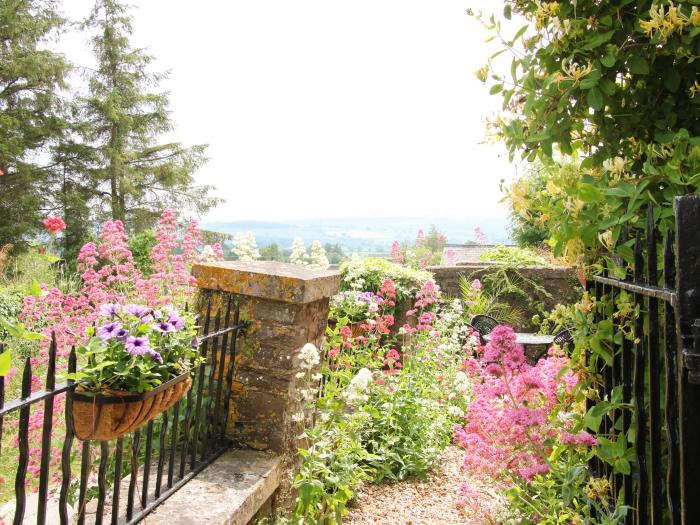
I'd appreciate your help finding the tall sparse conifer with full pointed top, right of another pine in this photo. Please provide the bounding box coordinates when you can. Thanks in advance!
[78,0,218,230]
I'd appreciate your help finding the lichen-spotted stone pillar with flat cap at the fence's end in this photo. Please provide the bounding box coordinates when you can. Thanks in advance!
[192,261,340,454]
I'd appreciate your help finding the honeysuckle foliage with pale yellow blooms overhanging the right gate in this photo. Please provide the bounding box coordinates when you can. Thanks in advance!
[479,0,700,259]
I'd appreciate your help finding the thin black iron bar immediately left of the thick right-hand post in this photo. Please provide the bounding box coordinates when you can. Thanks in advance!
[664,232,681,525]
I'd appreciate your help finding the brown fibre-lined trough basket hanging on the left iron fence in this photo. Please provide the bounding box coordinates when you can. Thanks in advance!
[71,372,192,441]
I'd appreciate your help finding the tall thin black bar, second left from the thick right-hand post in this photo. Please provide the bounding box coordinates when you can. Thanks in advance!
[637,209,663,525]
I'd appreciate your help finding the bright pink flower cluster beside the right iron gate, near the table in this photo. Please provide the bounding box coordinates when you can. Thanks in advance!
[454,326,580,481]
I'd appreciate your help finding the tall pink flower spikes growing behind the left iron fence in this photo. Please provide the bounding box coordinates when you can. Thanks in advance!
[14,210,223,492]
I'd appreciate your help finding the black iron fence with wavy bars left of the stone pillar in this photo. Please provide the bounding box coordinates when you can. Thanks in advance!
[0,292,246,525]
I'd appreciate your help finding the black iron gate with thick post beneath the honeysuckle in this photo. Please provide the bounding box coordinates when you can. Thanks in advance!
[591,196,700,525]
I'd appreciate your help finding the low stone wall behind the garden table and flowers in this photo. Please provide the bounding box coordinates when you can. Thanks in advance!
[429,263,582,330]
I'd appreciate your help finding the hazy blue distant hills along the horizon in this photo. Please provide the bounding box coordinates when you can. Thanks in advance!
[202,217,509,253]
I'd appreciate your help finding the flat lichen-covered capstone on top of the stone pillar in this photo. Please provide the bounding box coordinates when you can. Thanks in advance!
[192,261,340,304]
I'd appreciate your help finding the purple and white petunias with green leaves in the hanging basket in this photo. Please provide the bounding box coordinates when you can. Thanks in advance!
[68,303,202,393]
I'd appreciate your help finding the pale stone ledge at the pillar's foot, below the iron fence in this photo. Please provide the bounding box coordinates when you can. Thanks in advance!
[146,450,281,525]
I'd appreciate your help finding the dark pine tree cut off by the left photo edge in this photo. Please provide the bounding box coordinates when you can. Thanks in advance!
[0,0,70,246]
